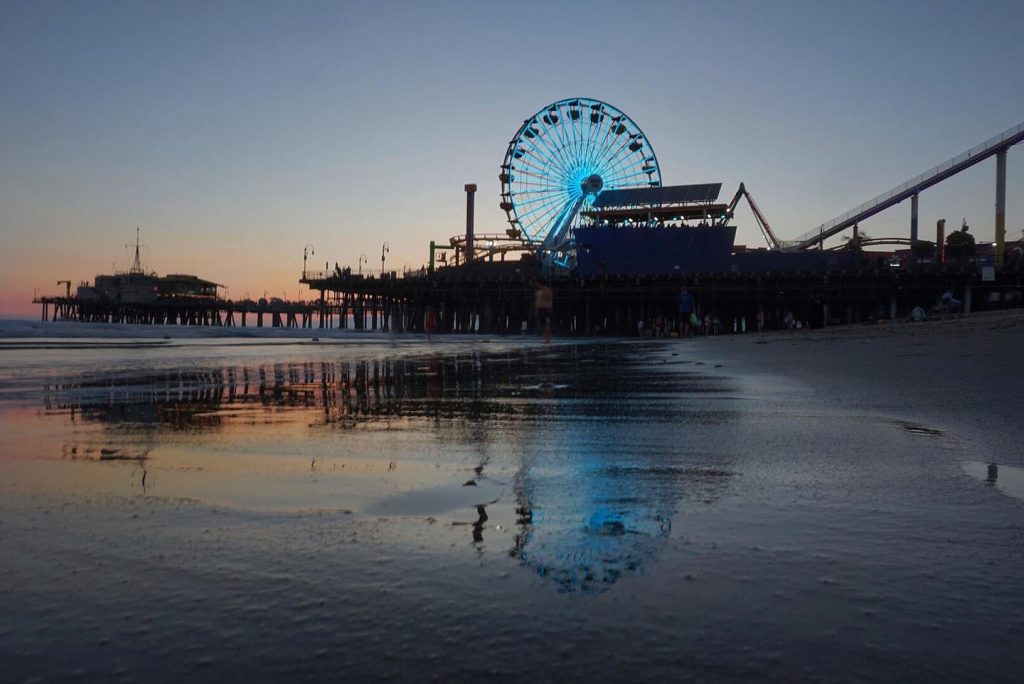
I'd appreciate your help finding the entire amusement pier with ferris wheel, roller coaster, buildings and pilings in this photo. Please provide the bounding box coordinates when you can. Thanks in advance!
[35,98,1024,336]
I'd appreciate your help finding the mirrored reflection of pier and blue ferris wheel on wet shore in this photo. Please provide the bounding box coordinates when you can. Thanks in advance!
[25,345,732,593]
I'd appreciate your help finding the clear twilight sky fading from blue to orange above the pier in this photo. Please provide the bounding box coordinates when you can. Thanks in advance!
[0,0,1024,313]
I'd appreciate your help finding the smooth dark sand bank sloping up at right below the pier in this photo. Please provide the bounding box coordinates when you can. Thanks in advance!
[694,309,1024,466]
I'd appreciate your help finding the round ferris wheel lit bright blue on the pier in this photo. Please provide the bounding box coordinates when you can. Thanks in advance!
[500,97,662,250]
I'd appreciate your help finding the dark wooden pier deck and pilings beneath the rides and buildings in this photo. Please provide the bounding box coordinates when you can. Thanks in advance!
[35,261,1024,336]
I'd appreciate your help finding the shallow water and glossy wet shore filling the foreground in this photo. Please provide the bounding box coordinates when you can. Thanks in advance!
[0,331,1024,681]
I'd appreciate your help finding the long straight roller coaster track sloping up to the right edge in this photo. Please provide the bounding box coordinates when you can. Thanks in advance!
[780,123,1024,250]
